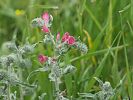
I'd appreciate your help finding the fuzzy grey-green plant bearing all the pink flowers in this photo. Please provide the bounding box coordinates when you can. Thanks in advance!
[27,12,88,100]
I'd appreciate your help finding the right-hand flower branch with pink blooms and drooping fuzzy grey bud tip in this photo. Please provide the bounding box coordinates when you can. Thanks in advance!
[55,32,88,55]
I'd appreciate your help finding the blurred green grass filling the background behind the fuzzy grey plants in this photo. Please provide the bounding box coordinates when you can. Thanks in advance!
[0,0,133,100]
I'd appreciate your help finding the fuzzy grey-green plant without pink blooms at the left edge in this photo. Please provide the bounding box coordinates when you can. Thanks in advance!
[0,41,35,100]
